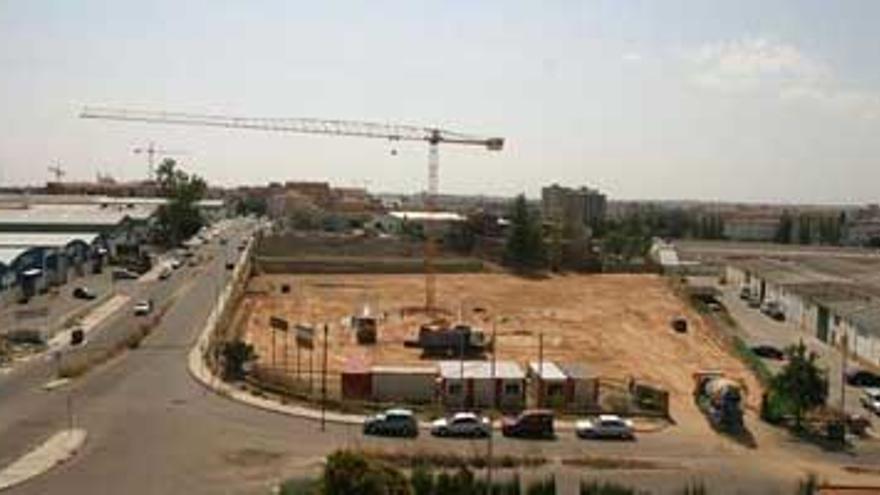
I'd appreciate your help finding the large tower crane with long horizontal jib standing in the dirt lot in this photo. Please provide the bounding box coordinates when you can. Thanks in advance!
[80,107,504,313]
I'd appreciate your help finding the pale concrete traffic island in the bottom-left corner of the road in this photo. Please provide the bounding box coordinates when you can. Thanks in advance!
[0,428,88,491]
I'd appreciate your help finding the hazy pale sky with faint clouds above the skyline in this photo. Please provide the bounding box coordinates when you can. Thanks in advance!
[0,0,880,203]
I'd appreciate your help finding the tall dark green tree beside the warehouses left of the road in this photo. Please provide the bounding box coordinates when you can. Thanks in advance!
[156,158,208,246]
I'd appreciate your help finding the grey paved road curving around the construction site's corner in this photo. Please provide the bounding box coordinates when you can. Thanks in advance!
[0,233,880,494]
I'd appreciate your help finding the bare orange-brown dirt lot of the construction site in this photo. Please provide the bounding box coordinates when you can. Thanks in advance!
[239,274,760,415]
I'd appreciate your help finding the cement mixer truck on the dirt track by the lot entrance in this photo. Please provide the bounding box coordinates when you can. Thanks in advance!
[694,371,744,433]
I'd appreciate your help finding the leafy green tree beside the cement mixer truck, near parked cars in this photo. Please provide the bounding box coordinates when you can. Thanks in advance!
[770,341,828,429]
